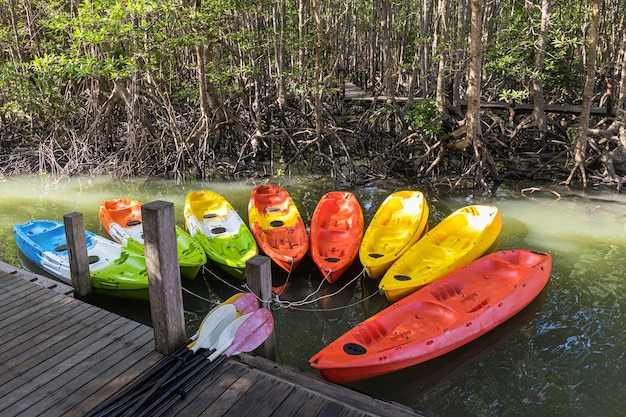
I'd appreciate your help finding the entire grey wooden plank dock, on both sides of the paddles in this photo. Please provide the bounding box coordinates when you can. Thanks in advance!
[0,262,424,417]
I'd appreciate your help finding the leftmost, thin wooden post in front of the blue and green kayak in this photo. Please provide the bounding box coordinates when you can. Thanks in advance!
[63,212,93,302]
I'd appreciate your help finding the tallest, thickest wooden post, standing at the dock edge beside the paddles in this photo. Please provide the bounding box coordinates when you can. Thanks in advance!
[141,201,186,355]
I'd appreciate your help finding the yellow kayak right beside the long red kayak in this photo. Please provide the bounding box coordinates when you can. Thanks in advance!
[378,205,502,302]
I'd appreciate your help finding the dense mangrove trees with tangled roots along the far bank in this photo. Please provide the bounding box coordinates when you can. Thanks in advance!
[0,0,626,189]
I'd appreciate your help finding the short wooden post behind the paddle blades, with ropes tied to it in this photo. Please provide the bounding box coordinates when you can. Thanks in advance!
[246,255,276,361]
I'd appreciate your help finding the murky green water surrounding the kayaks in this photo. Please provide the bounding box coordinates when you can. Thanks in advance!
[0,177,626,417]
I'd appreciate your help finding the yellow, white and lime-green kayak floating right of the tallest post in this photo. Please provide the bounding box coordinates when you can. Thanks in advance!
[184,190,258,280]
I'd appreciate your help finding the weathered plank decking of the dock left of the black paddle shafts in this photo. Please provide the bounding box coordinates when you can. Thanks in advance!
[0,262,158,416]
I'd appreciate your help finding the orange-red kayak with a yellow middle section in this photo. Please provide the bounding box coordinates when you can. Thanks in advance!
[248,184,309,272]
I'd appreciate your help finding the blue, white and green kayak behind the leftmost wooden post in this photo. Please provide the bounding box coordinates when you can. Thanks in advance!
[13,220,149,301]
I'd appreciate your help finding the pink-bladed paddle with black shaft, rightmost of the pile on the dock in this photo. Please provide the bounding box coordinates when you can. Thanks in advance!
[147,308,274,417]
